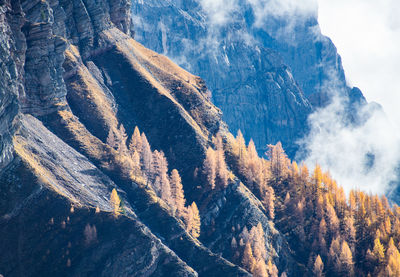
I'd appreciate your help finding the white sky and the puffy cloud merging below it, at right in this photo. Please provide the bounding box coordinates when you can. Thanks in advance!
[300,0,400,194]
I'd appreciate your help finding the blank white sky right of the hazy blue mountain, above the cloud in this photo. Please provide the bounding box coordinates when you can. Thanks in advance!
[318,0,400,127]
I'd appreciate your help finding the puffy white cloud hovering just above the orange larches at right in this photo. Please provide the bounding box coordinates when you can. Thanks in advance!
[300,90,400,194]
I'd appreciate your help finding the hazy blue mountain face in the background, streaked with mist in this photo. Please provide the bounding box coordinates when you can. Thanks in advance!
[132,0,366,157]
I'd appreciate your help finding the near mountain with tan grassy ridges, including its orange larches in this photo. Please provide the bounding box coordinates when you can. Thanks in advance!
[0,0,400,277]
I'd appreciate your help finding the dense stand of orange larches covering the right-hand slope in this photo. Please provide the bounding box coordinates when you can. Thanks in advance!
[227,132,400,276]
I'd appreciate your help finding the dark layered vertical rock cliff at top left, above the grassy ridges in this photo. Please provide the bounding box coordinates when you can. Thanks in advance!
[15,0,135,116]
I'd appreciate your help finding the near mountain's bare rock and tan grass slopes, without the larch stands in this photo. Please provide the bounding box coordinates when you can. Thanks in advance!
[0,0,300,276]
